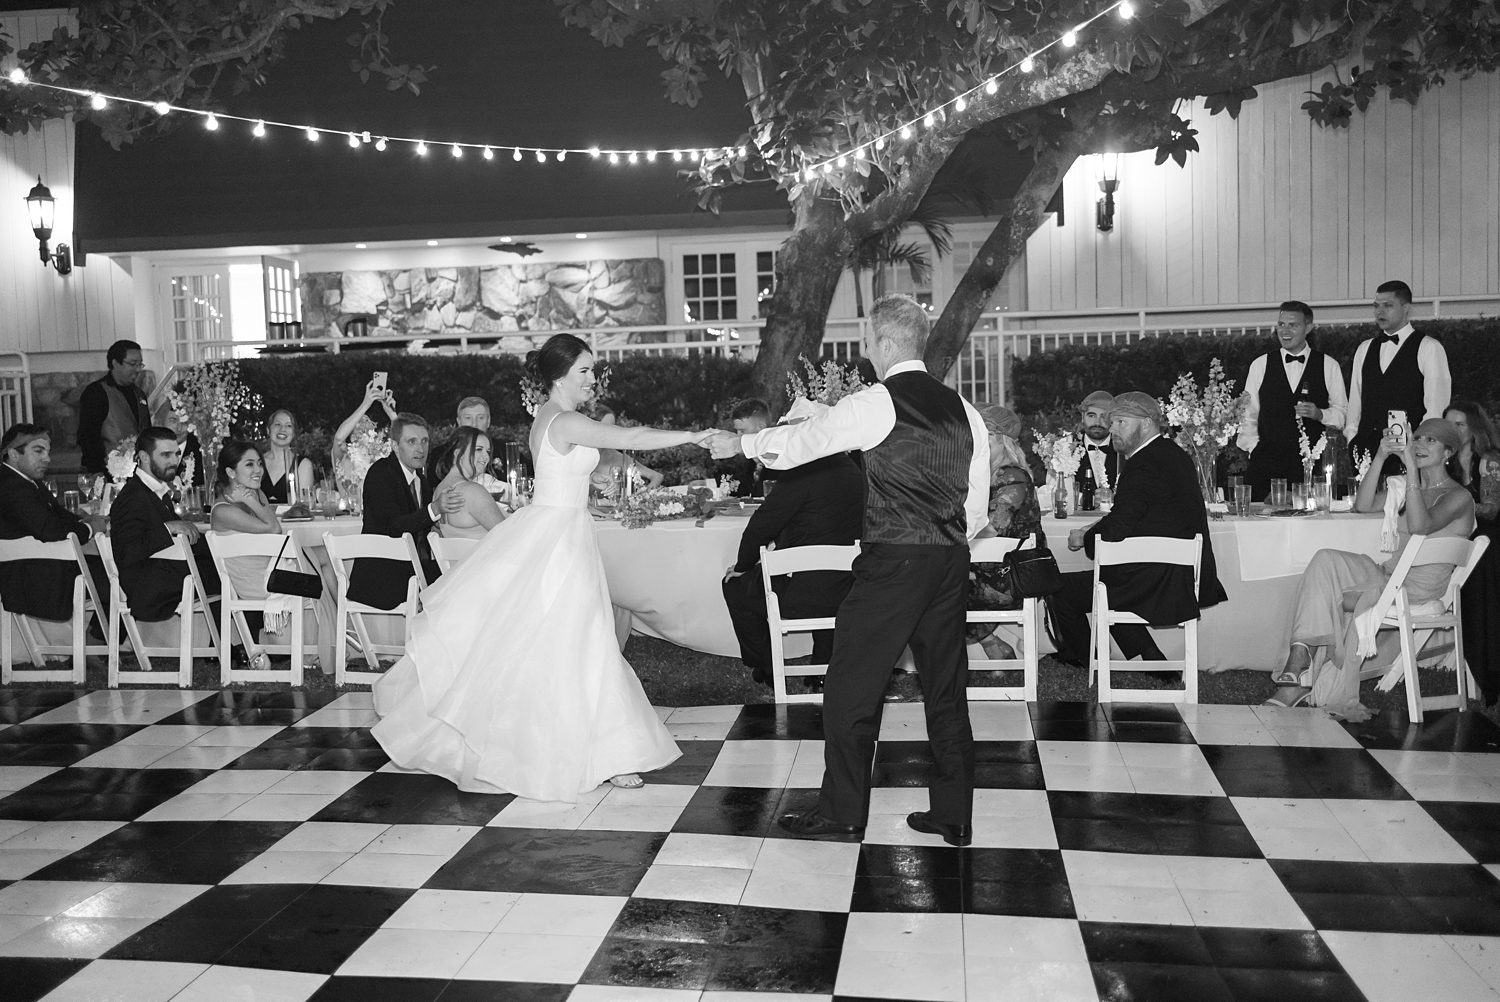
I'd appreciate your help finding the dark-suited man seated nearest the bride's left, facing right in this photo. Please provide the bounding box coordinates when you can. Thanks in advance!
[350,414,464,609]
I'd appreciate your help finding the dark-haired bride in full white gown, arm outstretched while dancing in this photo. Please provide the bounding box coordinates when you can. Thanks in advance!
[372,335,713,803]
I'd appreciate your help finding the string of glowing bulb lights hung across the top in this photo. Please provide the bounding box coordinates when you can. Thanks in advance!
[6,0,1136,173]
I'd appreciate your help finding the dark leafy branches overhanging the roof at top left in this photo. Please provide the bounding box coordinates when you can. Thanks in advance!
[0,0,432,147]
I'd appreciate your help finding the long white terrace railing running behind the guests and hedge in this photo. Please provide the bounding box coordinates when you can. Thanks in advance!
[178,296,1500,408]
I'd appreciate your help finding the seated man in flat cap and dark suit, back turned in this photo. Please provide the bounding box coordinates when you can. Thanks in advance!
[1047,392,1229,666]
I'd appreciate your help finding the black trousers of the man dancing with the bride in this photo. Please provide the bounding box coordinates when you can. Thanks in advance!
[818,543,974,825]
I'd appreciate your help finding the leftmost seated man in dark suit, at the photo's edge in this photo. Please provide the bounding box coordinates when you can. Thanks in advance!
[0,423,110,629]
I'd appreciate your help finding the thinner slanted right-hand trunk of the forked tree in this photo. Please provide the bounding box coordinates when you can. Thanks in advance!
[926,144,1088,380]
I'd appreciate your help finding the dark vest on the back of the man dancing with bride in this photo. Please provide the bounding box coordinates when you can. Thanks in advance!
[863,371,974,546]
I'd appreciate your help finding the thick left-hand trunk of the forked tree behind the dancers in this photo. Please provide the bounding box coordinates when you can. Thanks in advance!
[750,197,854,411]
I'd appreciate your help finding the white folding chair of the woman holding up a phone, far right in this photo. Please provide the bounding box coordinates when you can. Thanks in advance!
[1362,536,1490,723]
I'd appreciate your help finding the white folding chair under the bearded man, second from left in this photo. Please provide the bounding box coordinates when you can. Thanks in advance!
[96,536,219,689]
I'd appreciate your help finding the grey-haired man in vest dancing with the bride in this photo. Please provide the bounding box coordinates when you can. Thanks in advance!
[713,296,990,846]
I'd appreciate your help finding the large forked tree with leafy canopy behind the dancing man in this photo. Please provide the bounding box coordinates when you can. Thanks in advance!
[554,0,1500,398]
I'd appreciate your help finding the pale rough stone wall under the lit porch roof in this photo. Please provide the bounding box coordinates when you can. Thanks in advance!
[302,258,666,338]
